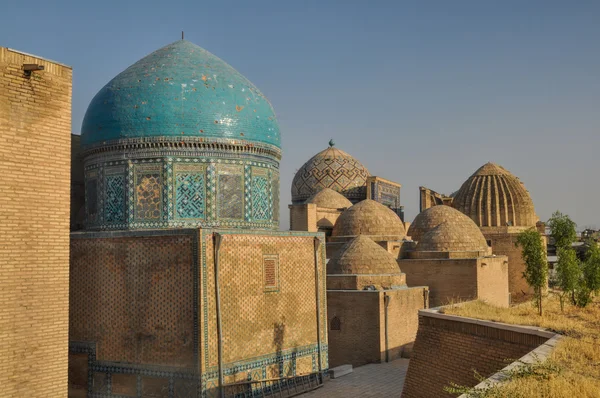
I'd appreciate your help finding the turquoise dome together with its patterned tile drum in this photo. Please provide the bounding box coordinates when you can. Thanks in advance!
[81,40,281,230]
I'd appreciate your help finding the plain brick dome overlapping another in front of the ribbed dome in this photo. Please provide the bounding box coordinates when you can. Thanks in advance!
[416,221,488,252]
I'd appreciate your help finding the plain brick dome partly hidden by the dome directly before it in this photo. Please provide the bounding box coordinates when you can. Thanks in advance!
[407,205,480,242]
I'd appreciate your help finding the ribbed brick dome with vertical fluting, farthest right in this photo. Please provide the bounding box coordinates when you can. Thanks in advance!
[452,163,539,227]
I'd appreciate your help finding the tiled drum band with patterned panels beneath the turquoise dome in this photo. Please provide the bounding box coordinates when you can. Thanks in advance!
[85,156,279,230]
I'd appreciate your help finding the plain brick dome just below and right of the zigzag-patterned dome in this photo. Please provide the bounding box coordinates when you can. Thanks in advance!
[332,199,406,239]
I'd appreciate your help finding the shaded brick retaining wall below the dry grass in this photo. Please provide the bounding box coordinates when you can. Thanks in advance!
[402,311,548,398]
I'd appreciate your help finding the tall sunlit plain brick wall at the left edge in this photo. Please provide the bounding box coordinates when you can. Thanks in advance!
[0,47,72,397]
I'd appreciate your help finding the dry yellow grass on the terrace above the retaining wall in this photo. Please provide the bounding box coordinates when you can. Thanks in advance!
[444,295,600,398]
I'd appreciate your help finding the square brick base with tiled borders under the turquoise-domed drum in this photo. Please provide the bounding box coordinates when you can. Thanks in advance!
[70,229,328,397]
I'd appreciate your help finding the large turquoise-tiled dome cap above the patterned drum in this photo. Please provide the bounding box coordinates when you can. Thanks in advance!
[81,40,280,148]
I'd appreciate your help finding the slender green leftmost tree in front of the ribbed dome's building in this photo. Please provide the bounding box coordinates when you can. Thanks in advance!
[515,228,548,315]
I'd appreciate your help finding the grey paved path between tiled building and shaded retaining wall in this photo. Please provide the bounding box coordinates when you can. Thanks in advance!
[300,359,408,398]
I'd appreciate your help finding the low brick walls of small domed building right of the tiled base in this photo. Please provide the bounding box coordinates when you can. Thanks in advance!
[327,288,425,367]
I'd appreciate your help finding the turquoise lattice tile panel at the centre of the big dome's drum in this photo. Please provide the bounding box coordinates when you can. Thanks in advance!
[175,172,206,218]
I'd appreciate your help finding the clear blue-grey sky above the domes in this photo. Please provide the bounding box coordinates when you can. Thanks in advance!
[0,0,600,229]
